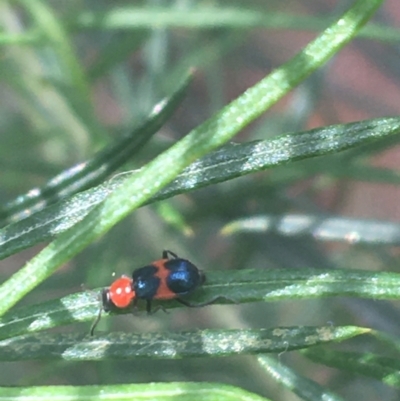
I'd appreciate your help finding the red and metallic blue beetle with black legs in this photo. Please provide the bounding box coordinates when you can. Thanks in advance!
[90,251,219,335]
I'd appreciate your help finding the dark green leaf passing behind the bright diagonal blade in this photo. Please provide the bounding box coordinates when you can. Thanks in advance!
[0,118,400,259]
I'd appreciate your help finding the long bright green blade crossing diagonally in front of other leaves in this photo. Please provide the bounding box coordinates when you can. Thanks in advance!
[0,0,382,314]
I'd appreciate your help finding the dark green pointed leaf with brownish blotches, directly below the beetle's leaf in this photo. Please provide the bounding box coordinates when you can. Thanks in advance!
[0,326,368,361]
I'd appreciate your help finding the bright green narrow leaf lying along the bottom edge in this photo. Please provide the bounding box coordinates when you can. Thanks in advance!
[0,382,268,401]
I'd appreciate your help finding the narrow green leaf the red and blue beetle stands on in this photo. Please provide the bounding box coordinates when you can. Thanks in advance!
[0,266,390,339]
